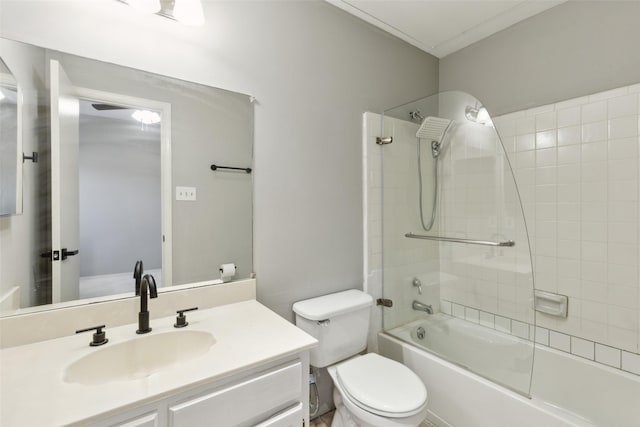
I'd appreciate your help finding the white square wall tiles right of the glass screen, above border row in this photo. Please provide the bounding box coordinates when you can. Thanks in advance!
[494,85,640,355]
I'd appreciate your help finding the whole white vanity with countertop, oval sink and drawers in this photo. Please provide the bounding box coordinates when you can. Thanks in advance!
[0,300,317,427]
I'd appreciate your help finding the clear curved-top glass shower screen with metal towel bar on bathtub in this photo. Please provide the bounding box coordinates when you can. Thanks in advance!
[380,92,535,394]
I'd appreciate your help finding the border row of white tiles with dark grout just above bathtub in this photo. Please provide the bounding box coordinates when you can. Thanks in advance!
[440,301,640,375]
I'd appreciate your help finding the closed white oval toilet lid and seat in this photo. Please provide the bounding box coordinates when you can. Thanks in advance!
[336,353,427,418]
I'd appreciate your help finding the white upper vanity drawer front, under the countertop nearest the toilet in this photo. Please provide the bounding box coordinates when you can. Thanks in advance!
[169,362,302,427]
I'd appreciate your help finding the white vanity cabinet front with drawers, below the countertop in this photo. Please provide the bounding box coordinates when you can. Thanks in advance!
[91,353,309,427]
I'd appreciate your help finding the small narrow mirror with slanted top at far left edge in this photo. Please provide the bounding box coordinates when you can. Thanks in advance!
[0,57,22,215]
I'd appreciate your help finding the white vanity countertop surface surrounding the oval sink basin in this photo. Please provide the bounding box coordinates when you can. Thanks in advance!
[0,300,317,427]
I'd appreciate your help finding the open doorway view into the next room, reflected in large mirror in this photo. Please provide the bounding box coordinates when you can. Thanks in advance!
[76,99,162,299]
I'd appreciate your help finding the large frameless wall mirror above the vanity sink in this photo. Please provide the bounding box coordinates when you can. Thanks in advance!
[0,39,253,315]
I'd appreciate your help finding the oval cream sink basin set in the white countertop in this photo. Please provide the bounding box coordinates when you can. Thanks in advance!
[63,331,215,385]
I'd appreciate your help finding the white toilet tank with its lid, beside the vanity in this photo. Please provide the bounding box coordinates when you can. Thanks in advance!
[293,289,373,368]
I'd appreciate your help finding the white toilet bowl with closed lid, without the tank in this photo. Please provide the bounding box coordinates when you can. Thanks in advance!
[327,353,427,427]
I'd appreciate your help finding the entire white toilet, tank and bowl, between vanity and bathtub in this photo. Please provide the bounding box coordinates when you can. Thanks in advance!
[293,289,427,427]
